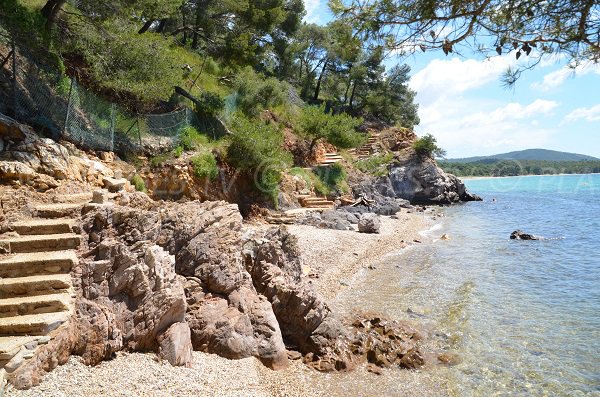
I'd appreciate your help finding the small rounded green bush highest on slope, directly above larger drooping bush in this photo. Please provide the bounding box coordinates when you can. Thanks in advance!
[234,68,289,117]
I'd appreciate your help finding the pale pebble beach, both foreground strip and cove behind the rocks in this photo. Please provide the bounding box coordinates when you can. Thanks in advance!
[5,209,437,397]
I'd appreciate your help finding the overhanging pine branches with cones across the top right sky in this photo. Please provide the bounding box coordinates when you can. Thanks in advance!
[329,0,600,81]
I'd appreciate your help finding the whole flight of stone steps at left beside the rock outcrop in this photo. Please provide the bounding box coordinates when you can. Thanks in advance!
[0,198,85,376]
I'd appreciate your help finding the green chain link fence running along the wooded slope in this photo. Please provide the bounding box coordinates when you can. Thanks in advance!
[0,27,194,153]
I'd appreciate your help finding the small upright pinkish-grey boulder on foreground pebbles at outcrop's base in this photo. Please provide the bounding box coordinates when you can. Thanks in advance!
[158,323,193,367]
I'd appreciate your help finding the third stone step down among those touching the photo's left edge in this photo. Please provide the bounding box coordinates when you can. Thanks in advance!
[0,274,72,299]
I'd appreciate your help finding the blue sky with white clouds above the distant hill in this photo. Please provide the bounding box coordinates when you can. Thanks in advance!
[304,0,600,158]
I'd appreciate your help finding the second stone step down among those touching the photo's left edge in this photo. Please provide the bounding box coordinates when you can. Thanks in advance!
[0,251,79,277]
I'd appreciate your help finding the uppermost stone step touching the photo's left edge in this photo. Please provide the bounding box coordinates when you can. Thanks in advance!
[0,233,81,254]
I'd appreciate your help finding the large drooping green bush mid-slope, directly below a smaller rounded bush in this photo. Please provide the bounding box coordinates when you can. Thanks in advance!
[227,116,292,202]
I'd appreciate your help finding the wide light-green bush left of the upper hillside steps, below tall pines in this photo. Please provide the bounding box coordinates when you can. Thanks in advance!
[297,105,365,149]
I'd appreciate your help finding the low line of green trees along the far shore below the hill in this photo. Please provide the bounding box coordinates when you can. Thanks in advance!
[439,160,600,176]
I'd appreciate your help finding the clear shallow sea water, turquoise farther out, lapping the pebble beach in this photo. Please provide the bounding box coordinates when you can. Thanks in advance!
[334,175,600,396]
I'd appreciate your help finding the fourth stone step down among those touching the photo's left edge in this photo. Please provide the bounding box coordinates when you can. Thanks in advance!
[0,294,71,318]
